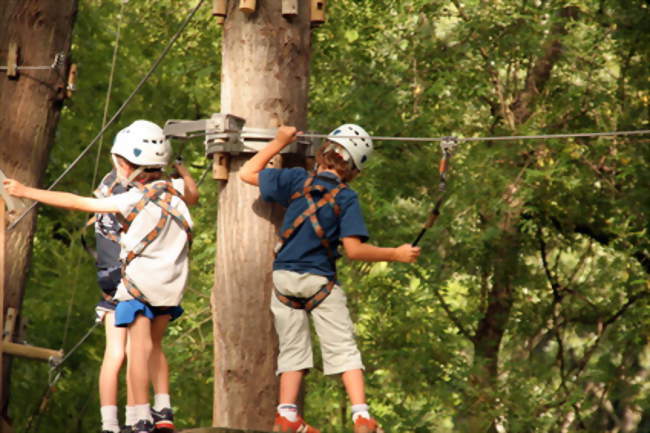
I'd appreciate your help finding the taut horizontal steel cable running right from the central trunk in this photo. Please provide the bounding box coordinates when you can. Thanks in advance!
[300,129,650,142]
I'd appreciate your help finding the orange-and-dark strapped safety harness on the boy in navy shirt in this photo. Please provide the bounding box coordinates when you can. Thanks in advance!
[275,173,347,313]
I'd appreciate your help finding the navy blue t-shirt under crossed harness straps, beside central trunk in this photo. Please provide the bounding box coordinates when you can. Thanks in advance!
[259,168,368,277]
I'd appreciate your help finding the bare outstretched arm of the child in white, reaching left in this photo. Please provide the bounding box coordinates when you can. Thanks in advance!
[2,179,120,213]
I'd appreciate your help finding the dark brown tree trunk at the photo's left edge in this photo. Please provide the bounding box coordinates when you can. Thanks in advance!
[0,0,77,418]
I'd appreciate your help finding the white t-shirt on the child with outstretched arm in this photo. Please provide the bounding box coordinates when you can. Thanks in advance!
[102,179,192,307]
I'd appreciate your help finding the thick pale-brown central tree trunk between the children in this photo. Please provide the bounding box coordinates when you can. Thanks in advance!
[212,0,311,430]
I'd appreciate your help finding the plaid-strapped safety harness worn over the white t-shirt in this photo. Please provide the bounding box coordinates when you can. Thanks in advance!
[122,180,192,304]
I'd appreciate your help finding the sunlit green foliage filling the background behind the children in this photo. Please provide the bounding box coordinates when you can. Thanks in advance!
[6,0,650,433]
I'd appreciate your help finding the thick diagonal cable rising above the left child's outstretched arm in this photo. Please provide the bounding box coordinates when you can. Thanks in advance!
[7,0,205,232]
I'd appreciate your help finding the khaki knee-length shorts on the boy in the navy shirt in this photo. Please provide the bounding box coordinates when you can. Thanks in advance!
[271,271,364,374]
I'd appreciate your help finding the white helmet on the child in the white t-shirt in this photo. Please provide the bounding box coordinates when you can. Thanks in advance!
[111,120,172,167]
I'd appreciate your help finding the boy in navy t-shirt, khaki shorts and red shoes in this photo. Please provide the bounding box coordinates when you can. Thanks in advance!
[239,124,420,433]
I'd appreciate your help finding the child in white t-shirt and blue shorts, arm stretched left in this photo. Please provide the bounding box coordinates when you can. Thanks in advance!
[3,120,192,433]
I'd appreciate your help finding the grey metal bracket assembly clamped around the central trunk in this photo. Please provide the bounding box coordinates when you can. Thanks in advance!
[163,113,315,156]
